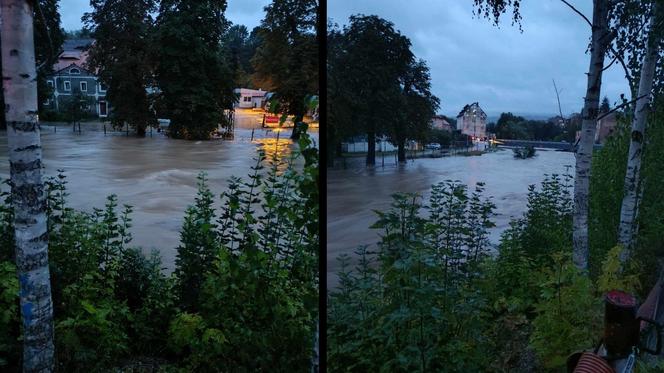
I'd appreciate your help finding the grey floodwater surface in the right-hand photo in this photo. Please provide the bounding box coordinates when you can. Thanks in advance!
[327,149,574,287]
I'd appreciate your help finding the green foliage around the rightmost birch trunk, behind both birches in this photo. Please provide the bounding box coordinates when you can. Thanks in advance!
[589,98,664,288]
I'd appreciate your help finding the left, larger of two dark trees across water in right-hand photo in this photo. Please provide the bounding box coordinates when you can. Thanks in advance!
[328,15,412,166]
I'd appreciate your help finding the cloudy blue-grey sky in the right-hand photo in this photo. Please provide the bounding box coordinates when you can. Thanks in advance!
[328,0,629,116]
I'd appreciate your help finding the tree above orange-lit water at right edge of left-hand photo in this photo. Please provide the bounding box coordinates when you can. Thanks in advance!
[253,0,319,139]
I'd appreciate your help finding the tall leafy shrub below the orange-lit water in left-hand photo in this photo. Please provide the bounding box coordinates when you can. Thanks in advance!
[170,131,319,371]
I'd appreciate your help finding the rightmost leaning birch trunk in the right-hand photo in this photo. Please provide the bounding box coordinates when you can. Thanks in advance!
[618,5,659,263]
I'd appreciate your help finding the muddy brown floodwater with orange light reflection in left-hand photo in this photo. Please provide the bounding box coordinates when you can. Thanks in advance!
[0,112,318,271]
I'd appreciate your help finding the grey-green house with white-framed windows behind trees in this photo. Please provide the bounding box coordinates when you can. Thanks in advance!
[43,39,111,118]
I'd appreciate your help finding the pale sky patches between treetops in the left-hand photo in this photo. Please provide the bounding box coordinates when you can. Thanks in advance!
[60,0,270,31]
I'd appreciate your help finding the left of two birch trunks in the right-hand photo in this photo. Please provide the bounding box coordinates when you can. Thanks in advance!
[572,0,611,270]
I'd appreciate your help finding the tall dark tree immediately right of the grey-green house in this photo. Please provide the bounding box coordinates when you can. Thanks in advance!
[83,0,156,136]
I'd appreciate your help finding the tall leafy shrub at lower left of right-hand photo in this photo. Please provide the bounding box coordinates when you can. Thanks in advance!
[328,181,494,372]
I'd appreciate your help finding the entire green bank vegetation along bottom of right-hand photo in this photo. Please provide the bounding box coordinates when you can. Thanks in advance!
[328,112,664,372]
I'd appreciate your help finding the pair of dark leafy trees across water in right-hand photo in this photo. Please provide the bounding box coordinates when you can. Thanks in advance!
[327,15,440,165]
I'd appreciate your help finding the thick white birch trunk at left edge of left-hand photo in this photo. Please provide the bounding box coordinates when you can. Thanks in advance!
[0,0,55,372]
